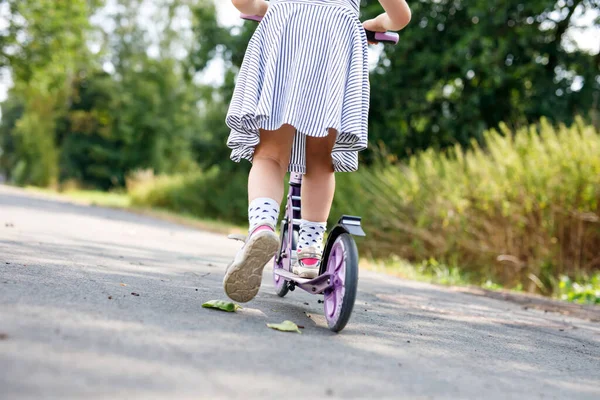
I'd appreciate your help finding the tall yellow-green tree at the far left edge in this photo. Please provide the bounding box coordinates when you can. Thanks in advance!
[0,0,94,185]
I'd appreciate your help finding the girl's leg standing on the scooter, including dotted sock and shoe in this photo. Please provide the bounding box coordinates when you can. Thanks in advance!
[294,130,337,278]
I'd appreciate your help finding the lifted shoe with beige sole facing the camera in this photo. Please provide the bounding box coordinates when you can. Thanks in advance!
[223,232,279,303]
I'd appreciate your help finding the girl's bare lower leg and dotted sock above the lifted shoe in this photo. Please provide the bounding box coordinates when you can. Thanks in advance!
[248,125,295,232]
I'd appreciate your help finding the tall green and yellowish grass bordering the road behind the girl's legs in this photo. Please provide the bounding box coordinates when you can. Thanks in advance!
[130,120,600,294]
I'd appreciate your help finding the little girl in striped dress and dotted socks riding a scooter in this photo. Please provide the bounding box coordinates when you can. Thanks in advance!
[223,0,410,302]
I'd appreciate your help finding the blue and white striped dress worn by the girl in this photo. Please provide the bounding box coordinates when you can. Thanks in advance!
[226,0,369,173]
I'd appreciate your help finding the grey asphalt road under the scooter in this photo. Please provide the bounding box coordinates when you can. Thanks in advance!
[0,186,600,400]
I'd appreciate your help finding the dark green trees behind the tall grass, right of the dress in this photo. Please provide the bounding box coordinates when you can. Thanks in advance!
[363,0,600,156]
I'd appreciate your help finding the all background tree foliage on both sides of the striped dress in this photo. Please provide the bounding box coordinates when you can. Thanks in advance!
[0,0,600,189]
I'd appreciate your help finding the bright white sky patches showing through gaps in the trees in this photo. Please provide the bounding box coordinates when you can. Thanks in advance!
[0,0,600,101]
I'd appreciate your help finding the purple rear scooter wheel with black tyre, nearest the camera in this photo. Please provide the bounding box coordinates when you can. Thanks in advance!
[323,233,358,332]
